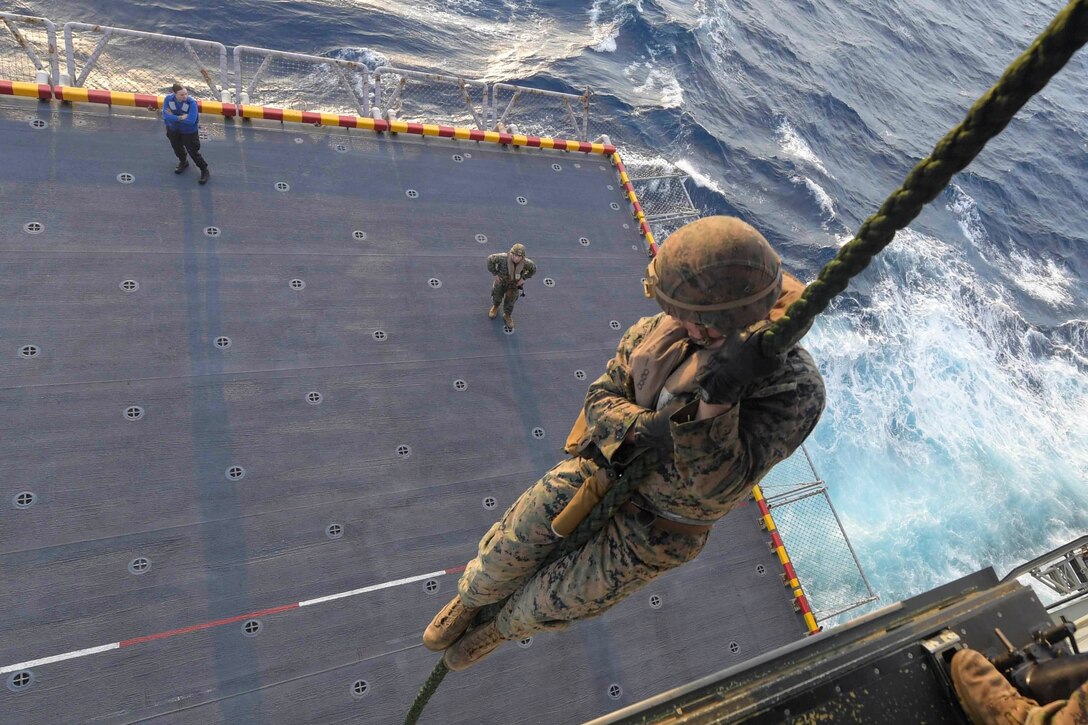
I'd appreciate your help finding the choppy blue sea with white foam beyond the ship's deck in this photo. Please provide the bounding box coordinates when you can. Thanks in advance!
[14,0,1088,602]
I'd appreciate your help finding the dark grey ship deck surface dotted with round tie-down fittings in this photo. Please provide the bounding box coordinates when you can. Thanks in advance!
[0,99,803,725]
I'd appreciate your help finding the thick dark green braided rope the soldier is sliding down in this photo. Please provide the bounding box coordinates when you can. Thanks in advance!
[405,0,1088,725]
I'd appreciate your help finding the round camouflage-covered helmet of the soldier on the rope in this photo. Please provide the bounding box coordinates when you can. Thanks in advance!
[645,217,782,331]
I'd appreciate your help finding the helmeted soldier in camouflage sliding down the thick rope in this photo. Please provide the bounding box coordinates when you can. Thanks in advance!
[423,217,824,669]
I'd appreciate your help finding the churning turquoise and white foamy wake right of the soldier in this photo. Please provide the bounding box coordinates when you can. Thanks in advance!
[805,229,1088,601]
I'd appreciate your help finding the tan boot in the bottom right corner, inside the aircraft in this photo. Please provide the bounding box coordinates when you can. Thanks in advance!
[952,650,1039,725]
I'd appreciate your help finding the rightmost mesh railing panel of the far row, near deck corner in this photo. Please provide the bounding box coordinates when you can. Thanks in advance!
[492,83,590,142]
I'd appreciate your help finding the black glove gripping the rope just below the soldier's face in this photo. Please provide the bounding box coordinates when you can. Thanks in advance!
[695,320,786,405]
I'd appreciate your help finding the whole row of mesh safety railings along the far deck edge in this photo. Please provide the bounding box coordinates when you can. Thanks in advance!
[0,13,604,139]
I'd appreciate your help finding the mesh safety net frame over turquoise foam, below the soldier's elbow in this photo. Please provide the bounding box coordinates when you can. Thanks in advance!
[766,478,877,623]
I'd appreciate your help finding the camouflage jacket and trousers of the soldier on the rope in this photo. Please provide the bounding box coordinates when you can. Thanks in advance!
[458,309,824,639]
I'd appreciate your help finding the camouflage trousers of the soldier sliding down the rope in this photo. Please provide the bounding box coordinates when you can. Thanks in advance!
[458,458,708,639]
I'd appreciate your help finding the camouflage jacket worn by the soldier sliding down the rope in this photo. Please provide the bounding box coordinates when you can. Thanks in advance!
[585,312,824,520]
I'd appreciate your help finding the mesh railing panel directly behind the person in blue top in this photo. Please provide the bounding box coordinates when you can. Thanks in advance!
[60,23,228,100]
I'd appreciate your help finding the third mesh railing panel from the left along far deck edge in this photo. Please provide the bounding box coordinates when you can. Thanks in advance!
[234,46,372,116]
